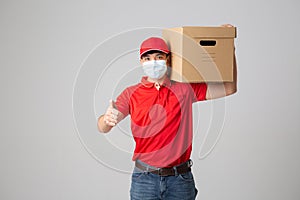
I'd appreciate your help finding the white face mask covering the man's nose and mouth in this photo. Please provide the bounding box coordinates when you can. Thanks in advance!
[143,60,167,79]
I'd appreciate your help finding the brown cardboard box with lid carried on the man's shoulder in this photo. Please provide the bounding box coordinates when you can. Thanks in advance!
[162,26,236,82]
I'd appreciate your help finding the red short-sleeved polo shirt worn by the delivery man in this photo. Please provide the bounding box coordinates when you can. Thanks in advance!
[116,77,207,167]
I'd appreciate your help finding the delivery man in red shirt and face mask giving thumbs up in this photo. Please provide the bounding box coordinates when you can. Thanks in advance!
[98,25,237,200]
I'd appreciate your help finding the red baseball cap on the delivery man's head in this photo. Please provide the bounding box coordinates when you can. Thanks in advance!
[140,37,170,57]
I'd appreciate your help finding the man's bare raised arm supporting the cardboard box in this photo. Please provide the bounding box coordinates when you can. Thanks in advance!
[206,54,237,100]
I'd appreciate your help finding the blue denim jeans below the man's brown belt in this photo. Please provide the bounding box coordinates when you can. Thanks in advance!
[130,162,197,200]
